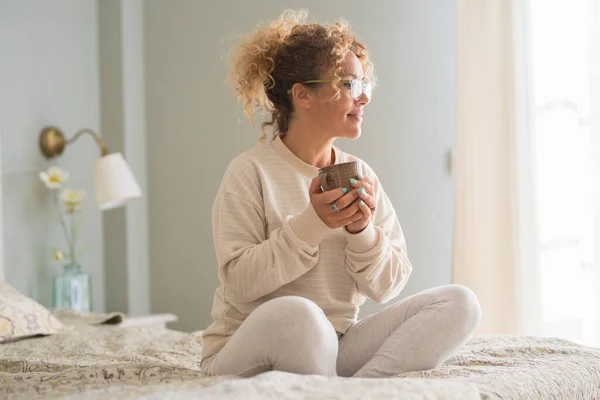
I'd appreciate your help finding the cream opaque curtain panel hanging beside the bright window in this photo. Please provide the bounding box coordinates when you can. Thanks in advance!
[453,0,541,334]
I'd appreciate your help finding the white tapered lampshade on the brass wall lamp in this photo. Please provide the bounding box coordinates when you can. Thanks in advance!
[94,153,142,210]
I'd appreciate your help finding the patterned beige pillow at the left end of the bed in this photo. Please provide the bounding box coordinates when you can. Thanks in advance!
[0,281,71,343]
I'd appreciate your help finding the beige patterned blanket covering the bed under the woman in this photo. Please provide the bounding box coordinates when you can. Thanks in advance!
[0,318,600,400]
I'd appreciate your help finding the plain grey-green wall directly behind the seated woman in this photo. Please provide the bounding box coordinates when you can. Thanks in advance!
[145,0,454,330]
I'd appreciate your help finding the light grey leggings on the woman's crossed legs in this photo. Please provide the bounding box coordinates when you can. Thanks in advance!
[202,285,481,377]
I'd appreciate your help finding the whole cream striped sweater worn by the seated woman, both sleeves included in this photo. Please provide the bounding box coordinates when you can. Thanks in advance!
[202,137,412,358]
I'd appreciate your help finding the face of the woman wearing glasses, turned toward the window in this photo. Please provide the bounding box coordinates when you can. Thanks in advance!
[311,51,370,139]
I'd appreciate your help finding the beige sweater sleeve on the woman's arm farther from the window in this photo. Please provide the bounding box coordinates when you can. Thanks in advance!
[213,188,330,302]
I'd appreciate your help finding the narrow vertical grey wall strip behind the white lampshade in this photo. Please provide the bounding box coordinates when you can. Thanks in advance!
[98,0,150,315]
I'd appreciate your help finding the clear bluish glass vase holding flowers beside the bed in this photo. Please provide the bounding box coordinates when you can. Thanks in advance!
[52,262,92,312]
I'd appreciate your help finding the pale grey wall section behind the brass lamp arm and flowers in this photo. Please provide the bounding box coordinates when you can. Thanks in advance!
[0,0,104,311]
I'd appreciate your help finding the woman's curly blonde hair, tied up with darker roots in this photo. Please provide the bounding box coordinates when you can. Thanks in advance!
[229,10,376,141]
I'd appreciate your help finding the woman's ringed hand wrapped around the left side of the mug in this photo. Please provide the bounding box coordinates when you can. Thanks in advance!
[309,178,363,229]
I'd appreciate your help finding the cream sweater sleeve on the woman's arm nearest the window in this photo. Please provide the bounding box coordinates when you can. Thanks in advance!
[344,173,412,303]
